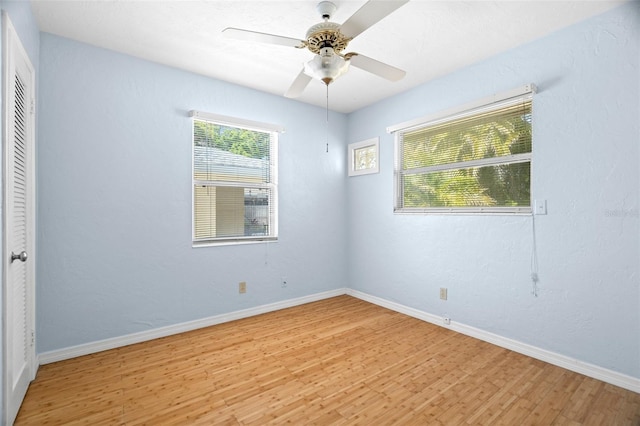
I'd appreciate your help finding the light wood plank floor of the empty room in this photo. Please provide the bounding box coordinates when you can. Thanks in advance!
[16,296,640,425]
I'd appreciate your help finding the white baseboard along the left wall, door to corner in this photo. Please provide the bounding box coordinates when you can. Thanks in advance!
[38,288,347,365]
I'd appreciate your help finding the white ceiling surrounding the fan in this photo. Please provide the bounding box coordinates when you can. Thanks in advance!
[31,0,625,113]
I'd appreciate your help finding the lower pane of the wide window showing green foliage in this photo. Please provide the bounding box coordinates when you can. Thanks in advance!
[401,162,531,208]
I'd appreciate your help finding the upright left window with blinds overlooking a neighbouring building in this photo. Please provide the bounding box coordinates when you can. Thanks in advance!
[191,111,281,245]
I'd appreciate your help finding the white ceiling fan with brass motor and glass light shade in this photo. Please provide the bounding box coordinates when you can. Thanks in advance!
[223,0,409,98]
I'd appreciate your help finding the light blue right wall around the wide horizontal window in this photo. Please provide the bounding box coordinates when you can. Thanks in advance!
[347,2,640,377]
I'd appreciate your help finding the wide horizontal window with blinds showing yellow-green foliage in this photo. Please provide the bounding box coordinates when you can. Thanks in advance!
[389,85,535,213]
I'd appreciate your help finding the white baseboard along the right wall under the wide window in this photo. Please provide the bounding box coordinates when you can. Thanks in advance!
[346,289,640,393]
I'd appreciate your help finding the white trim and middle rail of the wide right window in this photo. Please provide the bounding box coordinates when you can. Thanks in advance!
[387,83,537,215]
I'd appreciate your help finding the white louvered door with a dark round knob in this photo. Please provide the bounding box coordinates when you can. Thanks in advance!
[2,13,37,425]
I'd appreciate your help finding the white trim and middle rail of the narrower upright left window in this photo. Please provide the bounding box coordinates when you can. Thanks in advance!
[189,110,285,248]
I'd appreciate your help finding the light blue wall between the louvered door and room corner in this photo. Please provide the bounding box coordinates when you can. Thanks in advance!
[37,33,347,353]
